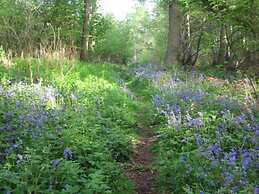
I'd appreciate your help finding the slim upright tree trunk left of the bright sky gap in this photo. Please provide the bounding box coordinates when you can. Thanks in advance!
[80,0,90,61]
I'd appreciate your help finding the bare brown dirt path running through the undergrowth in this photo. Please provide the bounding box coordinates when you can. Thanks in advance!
[126,128,157,194]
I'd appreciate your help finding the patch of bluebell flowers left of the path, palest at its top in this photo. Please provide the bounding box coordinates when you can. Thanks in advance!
[0,83,72,165]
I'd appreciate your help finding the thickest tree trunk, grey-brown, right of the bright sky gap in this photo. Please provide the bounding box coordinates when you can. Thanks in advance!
[164,3,181,65]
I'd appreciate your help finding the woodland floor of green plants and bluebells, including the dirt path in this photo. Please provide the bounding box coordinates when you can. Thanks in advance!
[0,59,259,194]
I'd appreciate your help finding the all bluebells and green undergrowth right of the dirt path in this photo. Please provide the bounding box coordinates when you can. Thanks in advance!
[137,67,259,193]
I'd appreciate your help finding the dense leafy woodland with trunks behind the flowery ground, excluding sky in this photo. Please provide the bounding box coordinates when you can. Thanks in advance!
[0,0,259,72]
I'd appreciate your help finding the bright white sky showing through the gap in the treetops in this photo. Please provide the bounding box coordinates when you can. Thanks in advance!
[100,0,154,19]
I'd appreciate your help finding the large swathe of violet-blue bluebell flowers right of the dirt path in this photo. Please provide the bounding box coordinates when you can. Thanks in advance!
[137,66,259,193]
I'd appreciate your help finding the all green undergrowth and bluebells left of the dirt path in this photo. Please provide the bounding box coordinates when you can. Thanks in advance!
[0,59,136,193]
